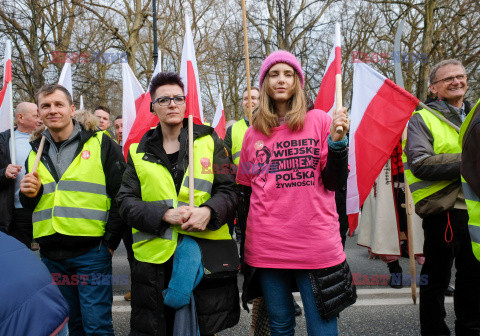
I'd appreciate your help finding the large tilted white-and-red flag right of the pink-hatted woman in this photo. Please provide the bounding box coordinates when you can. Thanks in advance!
[347,62,419,233]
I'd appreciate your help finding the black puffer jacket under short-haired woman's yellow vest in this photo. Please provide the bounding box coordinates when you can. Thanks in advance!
[117,119,240,335]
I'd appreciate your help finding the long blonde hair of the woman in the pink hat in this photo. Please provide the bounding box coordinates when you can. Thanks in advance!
[252,72,307,136]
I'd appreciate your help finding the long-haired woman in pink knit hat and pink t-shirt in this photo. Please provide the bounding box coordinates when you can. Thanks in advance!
[237,51,356,336]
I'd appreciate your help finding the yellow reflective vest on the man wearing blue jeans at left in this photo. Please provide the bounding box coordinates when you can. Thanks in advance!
[28,132,111,238]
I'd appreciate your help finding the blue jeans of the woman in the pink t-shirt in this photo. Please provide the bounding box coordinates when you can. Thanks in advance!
[258,268,338,336]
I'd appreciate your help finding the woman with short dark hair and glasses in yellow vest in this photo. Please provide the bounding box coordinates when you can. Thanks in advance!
[117,73,239,335]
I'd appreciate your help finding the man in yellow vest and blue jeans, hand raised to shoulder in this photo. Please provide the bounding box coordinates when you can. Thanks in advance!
[20,84,124,335]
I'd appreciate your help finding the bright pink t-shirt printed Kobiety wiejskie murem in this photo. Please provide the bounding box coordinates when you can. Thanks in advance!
[237,110,345,269]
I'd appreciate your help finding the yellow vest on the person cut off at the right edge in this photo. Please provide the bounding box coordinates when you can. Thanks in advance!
[459,100,480,260]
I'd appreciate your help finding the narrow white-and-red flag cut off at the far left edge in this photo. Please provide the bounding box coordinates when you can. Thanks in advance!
[0,40,13,132]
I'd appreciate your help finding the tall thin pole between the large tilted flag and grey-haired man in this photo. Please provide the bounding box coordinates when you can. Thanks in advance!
[393,19,417,304]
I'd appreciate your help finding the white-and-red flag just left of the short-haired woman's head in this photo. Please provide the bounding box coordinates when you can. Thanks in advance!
[122,57,162,160]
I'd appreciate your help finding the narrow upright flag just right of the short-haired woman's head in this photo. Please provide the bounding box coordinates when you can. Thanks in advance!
[180,14,204,125]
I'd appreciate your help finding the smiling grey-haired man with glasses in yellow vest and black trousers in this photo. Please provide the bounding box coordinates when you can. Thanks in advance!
[404,60,480,335]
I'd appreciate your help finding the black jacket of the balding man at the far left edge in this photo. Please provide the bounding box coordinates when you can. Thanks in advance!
[0,130,14,232]
